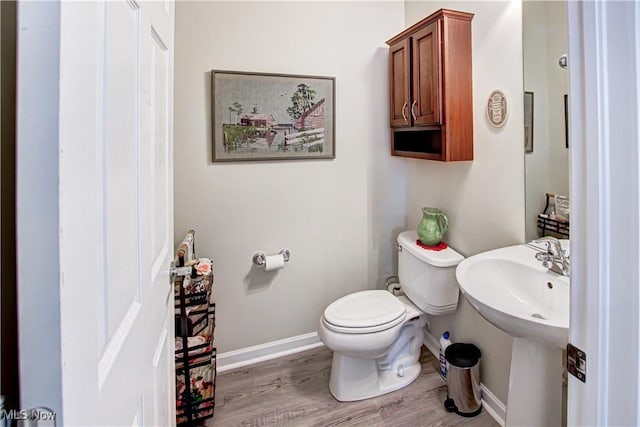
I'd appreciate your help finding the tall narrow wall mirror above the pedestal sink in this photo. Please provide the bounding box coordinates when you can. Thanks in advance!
[522,1,570,241]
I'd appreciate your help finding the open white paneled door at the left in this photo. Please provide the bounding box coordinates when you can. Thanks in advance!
[59,0,175,426]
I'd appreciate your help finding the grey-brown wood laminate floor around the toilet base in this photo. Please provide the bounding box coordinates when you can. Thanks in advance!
[205,347,498,427]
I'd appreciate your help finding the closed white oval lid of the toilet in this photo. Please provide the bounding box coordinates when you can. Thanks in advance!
[324,290,407,332]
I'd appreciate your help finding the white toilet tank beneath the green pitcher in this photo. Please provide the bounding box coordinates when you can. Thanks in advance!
[398,230,464,315]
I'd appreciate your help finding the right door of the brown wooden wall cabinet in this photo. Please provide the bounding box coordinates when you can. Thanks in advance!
[410,21,442,125]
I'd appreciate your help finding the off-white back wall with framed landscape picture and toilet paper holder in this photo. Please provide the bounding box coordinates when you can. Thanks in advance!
[174,1,406,352]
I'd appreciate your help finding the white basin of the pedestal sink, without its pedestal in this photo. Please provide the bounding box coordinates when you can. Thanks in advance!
[456,245,569,348]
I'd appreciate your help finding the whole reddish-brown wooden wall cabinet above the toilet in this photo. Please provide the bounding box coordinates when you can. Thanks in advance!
[387,9,473,161]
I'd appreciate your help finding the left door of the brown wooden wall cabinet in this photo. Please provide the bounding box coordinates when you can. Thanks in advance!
[389,38,411,127]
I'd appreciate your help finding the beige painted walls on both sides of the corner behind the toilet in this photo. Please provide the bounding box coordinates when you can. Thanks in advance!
[175,1,524,408]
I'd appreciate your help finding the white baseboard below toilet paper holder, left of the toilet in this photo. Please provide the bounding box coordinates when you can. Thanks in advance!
[216,332,324,372]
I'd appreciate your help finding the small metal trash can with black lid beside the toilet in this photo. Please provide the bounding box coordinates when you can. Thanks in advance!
[444,343,482,417]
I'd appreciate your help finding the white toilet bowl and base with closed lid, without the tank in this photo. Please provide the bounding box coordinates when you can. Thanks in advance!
[318,290,427,401]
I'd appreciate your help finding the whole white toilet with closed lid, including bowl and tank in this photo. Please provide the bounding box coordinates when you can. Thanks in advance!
[318,230,464,401]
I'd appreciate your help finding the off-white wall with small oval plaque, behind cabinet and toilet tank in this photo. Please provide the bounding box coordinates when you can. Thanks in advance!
[405,1,524,403]
